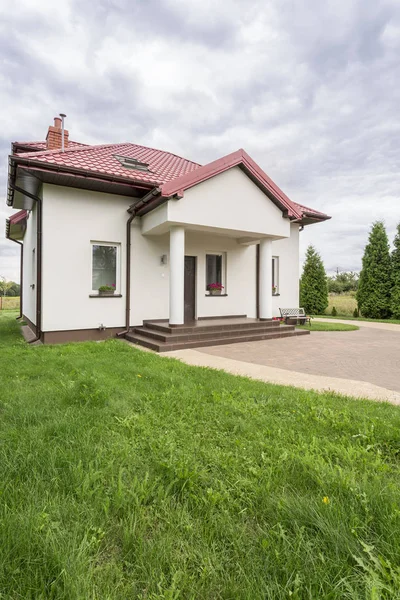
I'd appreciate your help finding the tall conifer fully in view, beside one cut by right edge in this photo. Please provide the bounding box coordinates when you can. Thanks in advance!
[356,221,391,319]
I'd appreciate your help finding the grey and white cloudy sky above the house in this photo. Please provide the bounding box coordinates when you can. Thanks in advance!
[0,0,400,280]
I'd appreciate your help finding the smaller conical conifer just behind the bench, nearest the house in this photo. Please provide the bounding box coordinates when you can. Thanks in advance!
[300,246,328,315]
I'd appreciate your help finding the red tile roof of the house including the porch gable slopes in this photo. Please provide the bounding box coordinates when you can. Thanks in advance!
[14,142,330,220]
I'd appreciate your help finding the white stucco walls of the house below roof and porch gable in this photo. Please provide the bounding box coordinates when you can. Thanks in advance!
[37,185,299,332]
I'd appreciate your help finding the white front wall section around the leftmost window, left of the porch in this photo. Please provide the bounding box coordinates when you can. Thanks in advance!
[42,184,131,332]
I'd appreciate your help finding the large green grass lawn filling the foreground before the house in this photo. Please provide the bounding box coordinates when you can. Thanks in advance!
[0,313,400,600]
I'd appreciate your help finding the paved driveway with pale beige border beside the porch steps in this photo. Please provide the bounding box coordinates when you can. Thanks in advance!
[165,322,400,404]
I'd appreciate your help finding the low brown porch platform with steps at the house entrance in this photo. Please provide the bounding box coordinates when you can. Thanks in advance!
[125,316,309,352]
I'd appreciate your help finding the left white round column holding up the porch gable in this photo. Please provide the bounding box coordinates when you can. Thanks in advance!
[169,226,185,325]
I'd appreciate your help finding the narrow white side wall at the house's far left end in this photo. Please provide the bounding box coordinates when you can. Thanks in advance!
[22,203,37,325]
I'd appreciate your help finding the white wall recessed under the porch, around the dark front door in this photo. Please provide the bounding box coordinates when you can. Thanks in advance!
[131,229,256,325]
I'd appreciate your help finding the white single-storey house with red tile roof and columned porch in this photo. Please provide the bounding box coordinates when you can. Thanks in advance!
[6,117,329,350]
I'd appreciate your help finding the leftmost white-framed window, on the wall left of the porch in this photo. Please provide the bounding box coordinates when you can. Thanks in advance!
[92,242,120,293]
